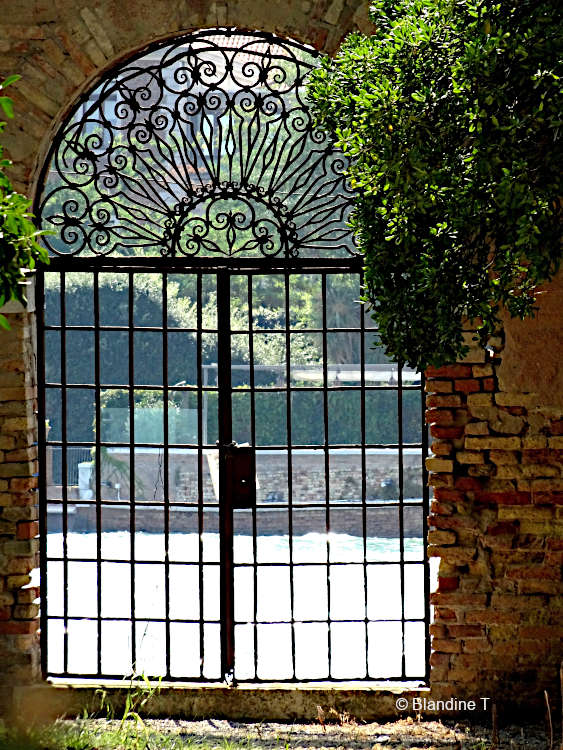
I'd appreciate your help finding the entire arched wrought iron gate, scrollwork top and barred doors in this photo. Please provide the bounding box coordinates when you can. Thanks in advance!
[36,30,429,682]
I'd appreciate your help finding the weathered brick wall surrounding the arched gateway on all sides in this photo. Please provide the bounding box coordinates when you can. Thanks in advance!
[0,0,563,724]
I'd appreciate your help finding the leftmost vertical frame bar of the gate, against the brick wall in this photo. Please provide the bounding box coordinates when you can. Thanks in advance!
[35,270,49,680]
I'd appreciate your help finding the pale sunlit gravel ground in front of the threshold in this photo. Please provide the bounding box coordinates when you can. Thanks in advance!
[89,717,560,750]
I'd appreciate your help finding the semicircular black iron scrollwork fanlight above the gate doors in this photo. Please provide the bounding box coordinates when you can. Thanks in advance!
[37,29,356,258]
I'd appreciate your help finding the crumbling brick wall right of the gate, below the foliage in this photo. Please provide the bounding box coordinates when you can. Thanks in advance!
[426,274,563,708]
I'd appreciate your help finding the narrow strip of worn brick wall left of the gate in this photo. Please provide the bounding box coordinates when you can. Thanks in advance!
[0,292,40,713]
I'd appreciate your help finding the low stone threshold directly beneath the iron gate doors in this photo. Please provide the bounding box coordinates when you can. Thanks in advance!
[12,679,430,722]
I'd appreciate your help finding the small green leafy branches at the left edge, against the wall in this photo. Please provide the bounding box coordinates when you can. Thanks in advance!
[0,75,48,328]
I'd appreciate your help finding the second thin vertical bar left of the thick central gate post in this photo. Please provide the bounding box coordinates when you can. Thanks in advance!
[162,272,170,677]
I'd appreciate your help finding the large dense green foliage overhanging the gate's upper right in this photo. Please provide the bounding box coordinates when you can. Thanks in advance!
[309,0,563,369]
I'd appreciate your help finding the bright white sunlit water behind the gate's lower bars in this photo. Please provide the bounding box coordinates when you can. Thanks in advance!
[47,531,434,680]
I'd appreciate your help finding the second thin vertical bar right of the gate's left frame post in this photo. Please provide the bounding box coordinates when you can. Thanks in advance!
[93,271,102,675]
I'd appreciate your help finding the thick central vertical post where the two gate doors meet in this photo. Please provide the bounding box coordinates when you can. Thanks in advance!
[217,268,235,680]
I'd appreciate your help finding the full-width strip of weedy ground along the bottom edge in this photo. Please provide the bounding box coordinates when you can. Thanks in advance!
[0,716,549,750]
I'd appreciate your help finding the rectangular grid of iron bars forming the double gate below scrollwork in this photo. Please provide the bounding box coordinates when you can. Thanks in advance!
[36,261,428,682]
